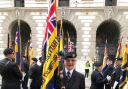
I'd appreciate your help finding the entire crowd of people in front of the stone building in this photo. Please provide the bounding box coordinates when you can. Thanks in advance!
[0,48,126,89]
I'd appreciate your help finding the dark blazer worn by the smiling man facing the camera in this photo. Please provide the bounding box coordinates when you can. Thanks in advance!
[56,70,85,89]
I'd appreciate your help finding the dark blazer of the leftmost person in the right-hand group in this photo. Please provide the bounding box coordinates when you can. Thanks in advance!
[90,69,107,89]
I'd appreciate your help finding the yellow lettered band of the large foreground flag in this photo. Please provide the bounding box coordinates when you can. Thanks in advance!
[42,29,59,89]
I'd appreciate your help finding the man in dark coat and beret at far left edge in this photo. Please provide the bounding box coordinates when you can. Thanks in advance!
[0,48,22,89]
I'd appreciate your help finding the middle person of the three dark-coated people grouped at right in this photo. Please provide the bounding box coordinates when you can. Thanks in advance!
[102,58,115,89]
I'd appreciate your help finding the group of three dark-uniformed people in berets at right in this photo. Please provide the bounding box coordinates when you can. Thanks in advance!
[90,57,123,89]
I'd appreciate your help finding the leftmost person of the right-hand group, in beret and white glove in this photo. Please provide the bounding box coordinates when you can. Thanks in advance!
[90,62,111,89]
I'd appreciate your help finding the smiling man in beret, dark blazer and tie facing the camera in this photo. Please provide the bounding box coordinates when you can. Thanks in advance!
[56,54,85,89]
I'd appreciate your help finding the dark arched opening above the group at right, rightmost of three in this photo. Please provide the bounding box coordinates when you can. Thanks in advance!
[96,19,121,61]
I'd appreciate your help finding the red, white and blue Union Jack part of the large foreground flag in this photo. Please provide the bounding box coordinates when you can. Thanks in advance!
[42,0,56,58]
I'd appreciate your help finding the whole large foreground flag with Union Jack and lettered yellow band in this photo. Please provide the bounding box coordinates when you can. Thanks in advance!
[42,0,59,89]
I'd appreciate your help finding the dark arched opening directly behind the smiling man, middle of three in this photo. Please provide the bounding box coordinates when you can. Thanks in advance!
[57,19,77,53]
